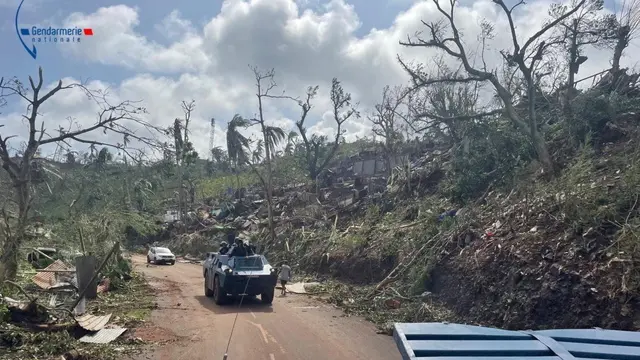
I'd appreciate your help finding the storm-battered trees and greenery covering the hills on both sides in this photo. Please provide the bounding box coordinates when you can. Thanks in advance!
[0,0,640,346]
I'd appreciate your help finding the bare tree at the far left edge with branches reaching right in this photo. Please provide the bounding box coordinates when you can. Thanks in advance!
[0,68,158,279]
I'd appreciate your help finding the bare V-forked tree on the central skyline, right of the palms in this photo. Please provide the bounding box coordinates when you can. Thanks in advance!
[294,78,360,186]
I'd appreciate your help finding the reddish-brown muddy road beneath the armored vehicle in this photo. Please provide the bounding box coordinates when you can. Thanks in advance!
[133,256,400,360]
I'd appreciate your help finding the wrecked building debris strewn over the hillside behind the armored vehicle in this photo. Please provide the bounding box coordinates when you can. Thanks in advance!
[156,149,451,259]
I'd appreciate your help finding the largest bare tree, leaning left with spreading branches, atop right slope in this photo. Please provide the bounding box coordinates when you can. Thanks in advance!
[398,0,586,173]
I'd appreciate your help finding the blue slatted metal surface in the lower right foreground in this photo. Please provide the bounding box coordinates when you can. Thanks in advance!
[393,323,640,360]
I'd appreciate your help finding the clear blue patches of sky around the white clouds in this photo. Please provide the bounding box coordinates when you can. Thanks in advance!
[0,0,411,83]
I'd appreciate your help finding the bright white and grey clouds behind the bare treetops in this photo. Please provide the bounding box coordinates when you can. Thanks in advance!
[2,0,638,160]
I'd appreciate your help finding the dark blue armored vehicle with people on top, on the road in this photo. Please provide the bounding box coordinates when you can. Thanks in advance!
[204,253,278,305]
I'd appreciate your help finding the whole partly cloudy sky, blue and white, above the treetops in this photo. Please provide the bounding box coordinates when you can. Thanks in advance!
[0,0,640,157]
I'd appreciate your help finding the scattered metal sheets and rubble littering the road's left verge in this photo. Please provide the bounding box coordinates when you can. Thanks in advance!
[0,243,151,359]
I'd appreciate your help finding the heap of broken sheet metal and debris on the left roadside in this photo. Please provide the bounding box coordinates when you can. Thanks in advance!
[0,243,142,359]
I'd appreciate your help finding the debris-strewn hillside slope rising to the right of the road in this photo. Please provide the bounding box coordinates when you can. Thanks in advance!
[171,109,640,329]
